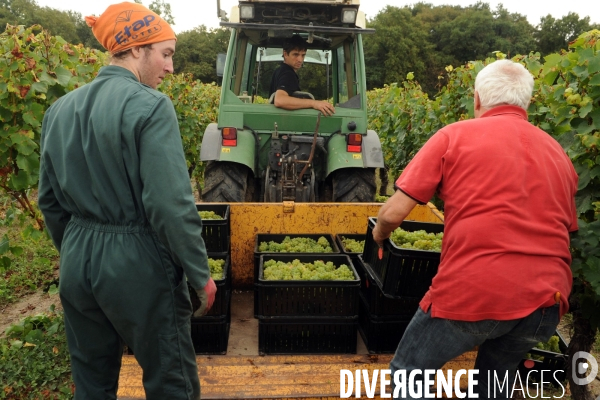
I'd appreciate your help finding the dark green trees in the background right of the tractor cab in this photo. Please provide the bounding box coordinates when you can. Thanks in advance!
[364,2,600,95]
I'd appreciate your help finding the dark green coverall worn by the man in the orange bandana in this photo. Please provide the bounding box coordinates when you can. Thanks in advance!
[39,66,210,400]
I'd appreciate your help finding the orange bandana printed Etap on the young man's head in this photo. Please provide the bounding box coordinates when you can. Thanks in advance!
[85,3,177,54]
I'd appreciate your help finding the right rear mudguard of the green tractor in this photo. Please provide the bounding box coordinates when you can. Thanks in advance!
[327,130,384,175]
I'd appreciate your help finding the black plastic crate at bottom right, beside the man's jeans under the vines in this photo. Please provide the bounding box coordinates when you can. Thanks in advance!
[519,331,568,387]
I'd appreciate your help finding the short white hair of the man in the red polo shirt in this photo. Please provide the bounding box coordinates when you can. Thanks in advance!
[475,60,533,110]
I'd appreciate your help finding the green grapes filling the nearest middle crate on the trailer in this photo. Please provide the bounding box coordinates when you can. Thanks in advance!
[263,260,355,281]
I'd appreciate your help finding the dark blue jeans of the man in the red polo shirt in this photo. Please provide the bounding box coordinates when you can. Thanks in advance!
[390,304,560,399]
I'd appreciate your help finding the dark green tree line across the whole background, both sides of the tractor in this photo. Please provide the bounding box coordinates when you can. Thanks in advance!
[0,0,600,95]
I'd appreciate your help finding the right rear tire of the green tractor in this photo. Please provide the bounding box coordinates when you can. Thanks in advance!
[332,168,377,203]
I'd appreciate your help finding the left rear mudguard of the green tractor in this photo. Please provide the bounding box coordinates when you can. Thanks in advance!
[200,123,256,173]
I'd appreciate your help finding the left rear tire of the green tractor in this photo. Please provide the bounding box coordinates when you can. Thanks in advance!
[202,161,255,203]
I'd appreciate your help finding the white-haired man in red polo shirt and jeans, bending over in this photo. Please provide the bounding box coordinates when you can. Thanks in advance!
[373,60,577,398]
